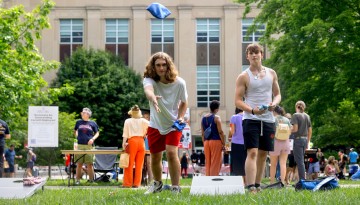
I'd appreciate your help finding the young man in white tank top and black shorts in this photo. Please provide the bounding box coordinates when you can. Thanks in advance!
[235,44,281,192]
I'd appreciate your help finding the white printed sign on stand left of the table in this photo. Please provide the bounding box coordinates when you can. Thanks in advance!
[28,106,59,147]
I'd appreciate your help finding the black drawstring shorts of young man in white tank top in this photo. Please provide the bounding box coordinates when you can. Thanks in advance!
[242,120,275,151]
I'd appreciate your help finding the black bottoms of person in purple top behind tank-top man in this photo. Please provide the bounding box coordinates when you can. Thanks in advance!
[230,143,247,176]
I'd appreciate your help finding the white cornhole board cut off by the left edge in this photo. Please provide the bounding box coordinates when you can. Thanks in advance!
[0,178,46,199]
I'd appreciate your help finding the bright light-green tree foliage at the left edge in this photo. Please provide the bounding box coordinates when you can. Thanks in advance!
[0,0,71,145]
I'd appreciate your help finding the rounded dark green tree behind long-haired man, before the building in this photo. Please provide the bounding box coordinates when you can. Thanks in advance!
[53,48,147,146]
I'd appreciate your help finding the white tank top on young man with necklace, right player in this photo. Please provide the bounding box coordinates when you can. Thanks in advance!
[243,67,275,123]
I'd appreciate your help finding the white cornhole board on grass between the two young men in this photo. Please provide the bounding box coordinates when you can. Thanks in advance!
[190,176,245,195]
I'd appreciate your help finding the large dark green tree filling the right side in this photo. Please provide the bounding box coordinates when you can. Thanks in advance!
[237,0,360,146]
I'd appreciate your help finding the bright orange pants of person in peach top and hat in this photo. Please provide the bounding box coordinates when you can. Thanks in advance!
[123,137,145,187]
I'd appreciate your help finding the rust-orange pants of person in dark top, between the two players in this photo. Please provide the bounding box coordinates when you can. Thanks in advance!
[204,140,222,176]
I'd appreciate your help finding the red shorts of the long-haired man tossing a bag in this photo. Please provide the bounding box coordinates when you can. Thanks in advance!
[147,127,182,153]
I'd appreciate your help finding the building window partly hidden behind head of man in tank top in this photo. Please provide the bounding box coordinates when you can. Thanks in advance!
[241,18,266,71]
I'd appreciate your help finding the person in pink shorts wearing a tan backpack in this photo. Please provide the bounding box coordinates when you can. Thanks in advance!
[269,106,291,187]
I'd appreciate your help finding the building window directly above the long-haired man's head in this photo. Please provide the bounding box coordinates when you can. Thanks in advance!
[151,19,175,59]
